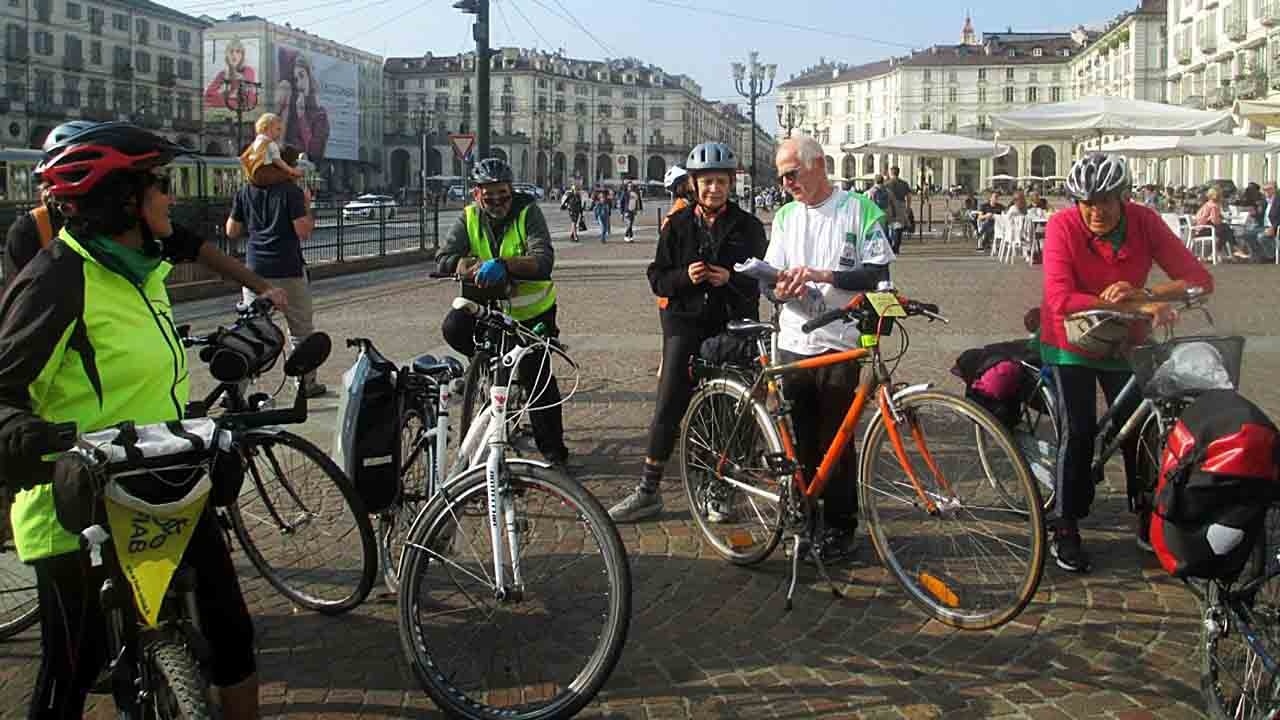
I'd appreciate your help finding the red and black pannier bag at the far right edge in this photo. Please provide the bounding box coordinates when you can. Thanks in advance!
[1151,389,1280,579]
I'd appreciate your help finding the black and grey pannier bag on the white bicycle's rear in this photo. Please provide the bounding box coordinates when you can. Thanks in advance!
[334,345,401,512]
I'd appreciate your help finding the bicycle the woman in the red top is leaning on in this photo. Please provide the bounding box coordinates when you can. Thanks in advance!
[977,288,1244,525]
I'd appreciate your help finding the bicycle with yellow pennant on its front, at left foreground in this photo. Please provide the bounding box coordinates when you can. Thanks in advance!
[28,334,329,720]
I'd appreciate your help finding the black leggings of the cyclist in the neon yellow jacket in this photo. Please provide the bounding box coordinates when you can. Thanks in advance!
[28,512,256,720]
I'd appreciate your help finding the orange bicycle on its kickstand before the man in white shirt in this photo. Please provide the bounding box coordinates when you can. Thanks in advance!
[680,290,1044,629]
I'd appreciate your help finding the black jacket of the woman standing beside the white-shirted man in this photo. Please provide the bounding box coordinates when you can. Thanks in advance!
[649,202,769,336]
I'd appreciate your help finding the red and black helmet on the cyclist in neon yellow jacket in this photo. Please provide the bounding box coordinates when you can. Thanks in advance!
[36,123,193,197]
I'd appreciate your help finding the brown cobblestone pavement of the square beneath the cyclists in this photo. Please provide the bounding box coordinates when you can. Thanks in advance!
[0,230,1280,720]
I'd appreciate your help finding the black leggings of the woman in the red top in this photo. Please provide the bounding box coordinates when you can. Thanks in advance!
[1051,365,1142,521]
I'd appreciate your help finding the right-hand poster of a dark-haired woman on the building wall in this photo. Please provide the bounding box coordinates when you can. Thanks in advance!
[271,45,360,160]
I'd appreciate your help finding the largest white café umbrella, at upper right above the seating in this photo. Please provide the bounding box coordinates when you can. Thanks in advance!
[991,96,1231,140]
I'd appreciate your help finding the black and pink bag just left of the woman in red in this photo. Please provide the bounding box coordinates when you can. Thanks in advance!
[951,340,1039,428]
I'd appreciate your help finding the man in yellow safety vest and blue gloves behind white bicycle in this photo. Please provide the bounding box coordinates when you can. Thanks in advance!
[435,158,568,465]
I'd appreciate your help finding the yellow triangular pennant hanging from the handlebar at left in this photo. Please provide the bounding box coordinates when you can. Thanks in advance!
[106,493,207,626]
